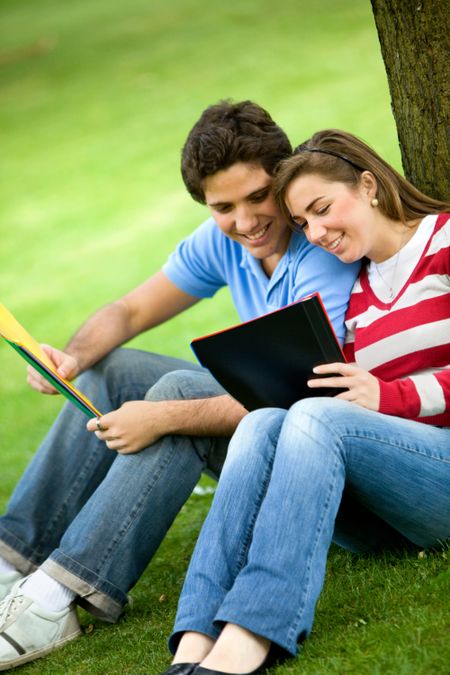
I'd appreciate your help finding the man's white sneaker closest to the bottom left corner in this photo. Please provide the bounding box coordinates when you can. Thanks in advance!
[0,580,81,670]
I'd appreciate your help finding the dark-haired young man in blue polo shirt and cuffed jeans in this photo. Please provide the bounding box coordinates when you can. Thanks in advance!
[0,101,358,669]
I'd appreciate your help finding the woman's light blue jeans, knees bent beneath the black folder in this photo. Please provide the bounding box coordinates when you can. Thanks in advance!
[169,398,450,654]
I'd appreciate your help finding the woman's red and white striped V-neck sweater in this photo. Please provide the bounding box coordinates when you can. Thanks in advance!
[344,214,450,427]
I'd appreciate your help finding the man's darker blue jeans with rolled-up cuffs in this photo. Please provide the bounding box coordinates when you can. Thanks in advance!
[0,349,228,621]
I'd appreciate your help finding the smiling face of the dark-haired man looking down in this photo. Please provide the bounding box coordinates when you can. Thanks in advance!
[203,162,291,276]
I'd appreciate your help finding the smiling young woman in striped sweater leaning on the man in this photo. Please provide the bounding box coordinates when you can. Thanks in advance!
[160,130,450,675]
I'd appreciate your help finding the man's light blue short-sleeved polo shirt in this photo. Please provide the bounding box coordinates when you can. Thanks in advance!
[163,218,360,342]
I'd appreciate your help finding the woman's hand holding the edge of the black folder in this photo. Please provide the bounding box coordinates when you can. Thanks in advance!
[308,363,380,410]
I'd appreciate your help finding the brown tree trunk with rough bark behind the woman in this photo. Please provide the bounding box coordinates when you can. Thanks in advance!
[371,0,450,201]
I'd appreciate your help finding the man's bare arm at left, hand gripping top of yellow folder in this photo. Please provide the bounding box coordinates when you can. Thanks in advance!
[28,271,199,394]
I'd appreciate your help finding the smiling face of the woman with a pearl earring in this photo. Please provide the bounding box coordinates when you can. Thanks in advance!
[285,172,377,263]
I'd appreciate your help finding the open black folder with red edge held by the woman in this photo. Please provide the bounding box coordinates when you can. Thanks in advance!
[191,293,345,410]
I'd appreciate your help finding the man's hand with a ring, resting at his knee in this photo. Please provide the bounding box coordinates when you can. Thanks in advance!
[86,401,163,455]
